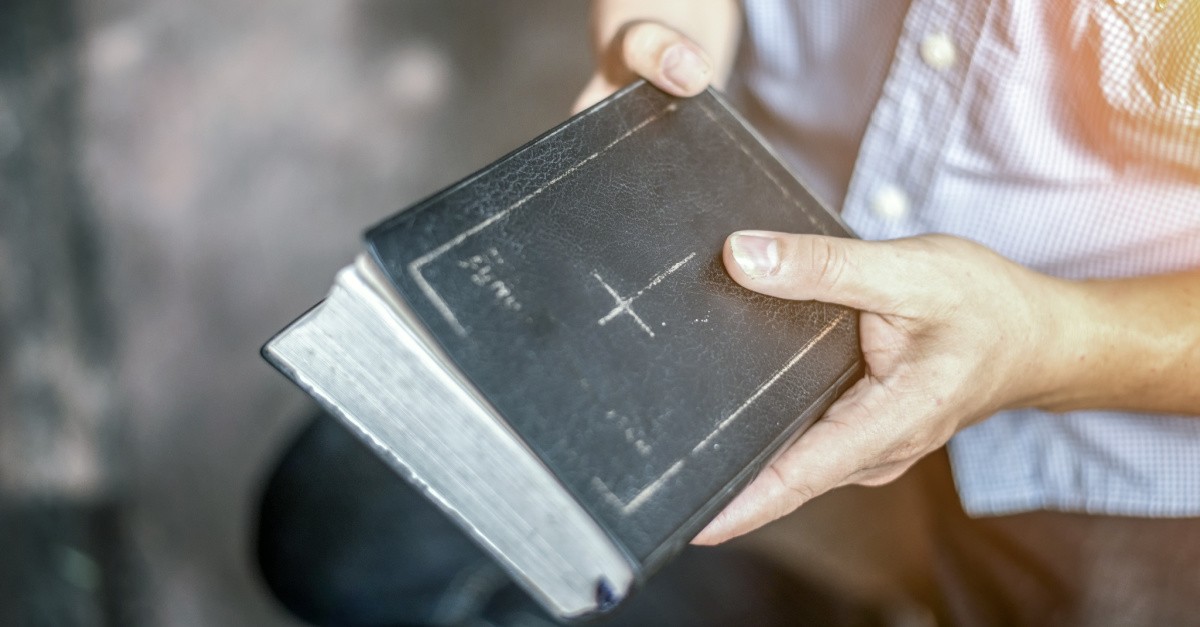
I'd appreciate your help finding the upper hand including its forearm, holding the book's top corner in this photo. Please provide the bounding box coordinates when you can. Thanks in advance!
[571,0,739,113]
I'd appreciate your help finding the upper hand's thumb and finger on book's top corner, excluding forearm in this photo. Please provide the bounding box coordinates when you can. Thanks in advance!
[571,20,713,113]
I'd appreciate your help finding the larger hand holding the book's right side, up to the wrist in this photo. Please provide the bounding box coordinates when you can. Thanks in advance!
[692,231,1075,544]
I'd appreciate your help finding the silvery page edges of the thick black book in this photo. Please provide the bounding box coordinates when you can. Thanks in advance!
[265,252,634,617]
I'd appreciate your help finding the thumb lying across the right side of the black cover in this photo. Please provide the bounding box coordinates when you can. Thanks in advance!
[722,231,929,314]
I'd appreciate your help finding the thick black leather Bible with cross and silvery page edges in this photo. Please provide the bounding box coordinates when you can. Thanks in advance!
[263,82,863,619]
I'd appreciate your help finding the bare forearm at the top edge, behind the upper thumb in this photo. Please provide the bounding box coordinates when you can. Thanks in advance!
[592,0,742,86]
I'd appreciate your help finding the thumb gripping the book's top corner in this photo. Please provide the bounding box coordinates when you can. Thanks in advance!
[620,22,713,96]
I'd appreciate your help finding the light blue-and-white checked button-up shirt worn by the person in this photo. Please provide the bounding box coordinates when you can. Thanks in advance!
[730,0,1200,516]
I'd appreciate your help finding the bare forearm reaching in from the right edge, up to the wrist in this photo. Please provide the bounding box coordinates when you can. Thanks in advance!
[1036,271,1200,414]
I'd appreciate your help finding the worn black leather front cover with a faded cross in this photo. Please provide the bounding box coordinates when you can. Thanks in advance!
[367,83,862,569]
